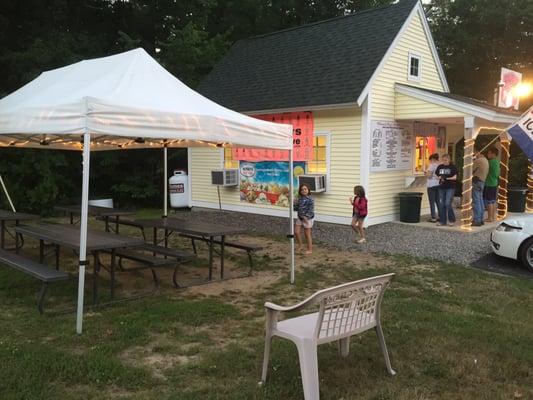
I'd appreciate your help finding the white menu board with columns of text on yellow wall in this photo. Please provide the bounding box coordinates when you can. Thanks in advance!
[370,121,414,171]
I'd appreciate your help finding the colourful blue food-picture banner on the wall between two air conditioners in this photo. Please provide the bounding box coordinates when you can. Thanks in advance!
[239,161,305,207]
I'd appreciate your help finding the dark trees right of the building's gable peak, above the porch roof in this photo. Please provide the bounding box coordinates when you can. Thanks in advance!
[428,0,533,105]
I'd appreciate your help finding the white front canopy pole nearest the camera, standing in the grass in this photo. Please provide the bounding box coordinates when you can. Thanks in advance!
[76,132,91,334]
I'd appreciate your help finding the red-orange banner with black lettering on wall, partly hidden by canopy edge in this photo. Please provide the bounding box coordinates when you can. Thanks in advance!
[232,111,314,161]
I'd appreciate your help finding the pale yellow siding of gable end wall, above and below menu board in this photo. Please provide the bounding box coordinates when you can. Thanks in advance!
[369,10,448,218]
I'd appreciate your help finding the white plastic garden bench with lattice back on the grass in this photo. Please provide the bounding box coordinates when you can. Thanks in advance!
[261,274,396,400]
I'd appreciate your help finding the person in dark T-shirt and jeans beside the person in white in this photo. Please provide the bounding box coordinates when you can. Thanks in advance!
[435,154,457,226]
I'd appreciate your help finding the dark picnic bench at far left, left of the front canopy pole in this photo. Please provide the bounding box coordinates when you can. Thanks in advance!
[0,249,69,314]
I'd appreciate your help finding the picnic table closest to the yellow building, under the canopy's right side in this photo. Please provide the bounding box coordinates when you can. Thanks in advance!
[135,218,246,280]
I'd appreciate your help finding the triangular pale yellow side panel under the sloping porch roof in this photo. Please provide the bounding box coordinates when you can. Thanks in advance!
[394,93,465,120]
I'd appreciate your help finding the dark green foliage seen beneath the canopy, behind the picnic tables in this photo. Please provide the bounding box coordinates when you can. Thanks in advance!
[0,149,187,215]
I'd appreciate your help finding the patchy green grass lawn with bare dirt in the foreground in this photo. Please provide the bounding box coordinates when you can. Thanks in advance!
[0,211,533,400]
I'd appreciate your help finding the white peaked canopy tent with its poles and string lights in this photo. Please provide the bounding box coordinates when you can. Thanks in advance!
[0,49,294,333]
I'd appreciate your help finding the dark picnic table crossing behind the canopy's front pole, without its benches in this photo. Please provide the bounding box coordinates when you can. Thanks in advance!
[14,224,144,304]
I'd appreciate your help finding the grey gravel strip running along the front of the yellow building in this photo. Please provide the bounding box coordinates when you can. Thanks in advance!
[172,209,492,265]
